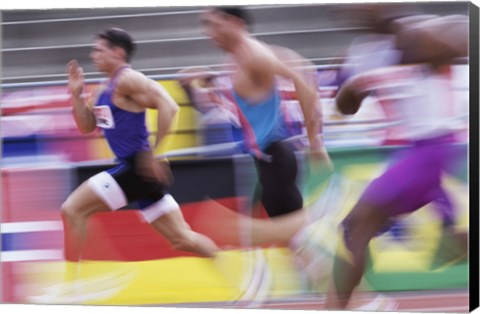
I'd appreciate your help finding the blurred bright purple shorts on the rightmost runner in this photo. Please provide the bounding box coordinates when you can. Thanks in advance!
[360,135,461,219]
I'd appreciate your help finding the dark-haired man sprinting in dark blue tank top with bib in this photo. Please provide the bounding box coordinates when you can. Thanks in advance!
[61,28,217,272]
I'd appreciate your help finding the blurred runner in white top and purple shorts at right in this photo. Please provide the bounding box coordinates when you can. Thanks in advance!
[310,8,468,311]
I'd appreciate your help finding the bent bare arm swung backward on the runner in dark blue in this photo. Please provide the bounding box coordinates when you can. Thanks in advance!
[117,71,178,150]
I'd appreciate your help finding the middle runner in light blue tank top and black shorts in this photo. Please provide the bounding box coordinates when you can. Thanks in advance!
[187,6,331,250]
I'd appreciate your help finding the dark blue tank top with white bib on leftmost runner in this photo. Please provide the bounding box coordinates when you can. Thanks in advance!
[93,67,150,160]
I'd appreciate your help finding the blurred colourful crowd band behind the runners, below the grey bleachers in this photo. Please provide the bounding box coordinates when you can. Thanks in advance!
[1,65,469,166]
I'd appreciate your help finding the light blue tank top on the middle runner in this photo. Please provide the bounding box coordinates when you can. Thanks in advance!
[233,86,289,151]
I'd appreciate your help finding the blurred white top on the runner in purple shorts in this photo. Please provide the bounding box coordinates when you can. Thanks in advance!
[361,65,454,140]
